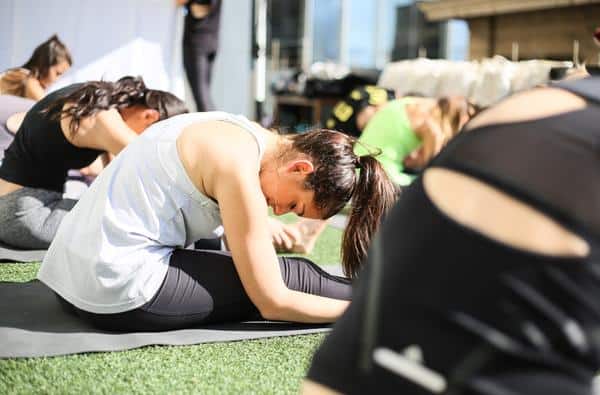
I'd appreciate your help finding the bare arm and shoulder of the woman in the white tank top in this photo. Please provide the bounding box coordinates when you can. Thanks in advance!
[184,122,348,323]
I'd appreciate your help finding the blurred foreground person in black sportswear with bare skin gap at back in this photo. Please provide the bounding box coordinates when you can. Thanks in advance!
[303,78,600,395]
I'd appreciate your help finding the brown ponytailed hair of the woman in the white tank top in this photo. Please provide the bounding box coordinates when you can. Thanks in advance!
[290,129,398,278]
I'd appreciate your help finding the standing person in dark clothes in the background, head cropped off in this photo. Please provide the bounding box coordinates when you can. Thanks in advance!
[175,0,221,111]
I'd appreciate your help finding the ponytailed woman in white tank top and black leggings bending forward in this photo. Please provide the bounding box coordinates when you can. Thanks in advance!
[38,112,395,330]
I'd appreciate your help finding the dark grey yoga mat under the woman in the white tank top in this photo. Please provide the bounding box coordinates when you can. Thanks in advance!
[0,280,329,358]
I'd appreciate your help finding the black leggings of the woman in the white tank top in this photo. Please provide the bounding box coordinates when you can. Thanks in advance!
[61,250,351,331]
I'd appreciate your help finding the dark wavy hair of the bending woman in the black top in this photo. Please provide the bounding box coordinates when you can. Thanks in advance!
[44,76,188,134]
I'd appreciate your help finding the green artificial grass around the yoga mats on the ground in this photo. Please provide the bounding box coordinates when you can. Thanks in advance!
[0,221,341,394]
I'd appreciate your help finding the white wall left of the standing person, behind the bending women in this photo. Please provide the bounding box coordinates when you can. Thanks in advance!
[0,0,183,96]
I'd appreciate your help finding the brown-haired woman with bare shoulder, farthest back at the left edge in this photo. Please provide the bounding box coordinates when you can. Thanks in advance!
[0,35,73,101]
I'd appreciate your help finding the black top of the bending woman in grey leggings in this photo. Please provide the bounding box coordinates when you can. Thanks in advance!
[0,84,102,193]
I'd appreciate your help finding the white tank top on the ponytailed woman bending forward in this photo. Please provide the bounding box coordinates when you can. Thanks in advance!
[38,112,264,313]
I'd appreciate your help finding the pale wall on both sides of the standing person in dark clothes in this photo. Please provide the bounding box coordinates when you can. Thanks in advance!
[0,0,253,116]
